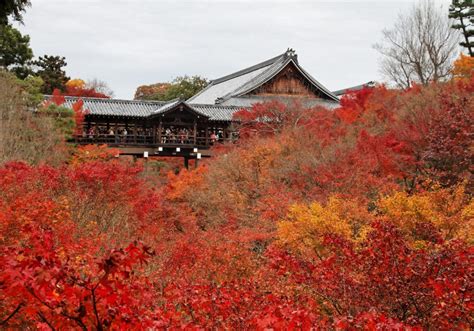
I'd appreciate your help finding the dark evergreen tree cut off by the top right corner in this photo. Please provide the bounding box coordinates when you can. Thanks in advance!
[449,0,474,56]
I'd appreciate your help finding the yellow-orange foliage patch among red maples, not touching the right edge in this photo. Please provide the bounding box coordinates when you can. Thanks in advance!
[277,196,372,256]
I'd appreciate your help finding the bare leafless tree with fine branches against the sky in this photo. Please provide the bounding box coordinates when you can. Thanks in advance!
[374,0,458,88]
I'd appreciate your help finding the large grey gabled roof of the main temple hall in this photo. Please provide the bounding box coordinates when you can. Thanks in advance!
[188,49,338,104]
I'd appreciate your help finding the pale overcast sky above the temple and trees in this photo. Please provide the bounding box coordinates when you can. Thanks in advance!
[16,0,449,99]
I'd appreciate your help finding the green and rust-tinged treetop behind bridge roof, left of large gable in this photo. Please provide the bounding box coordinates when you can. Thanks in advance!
[135,76,209,101]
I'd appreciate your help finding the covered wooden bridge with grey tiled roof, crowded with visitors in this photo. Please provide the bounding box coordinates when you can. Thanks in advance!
[64,97,240,164]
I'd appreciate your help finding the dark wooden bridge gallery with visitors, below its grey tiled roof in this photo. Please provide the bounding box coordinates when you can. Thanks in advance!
[74,103,236,166]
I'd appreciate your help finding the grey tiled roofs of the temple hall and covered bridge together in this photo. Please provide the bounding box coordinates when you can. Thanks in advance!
[45,49,364,121]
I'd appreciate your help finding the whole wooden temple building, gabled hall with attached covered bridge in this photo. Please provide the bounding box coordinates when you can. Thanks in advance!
[54,49,360,163]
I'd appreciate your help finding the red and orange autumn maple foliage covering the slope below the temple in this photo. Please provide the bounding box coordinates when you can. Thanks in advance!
[0,77,474,330]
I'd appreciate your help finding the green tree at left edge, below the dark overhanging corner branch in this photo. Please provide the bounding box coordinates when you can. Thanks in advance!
[0,25,33,79]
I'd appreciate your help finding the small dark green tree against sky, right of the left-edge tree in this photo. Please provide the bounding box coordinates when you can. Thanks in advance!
[33,55,69,94]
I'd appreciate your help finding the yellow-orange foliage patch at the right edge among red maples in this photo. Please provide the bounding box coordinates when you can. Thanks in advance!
[378,185,474,245]
